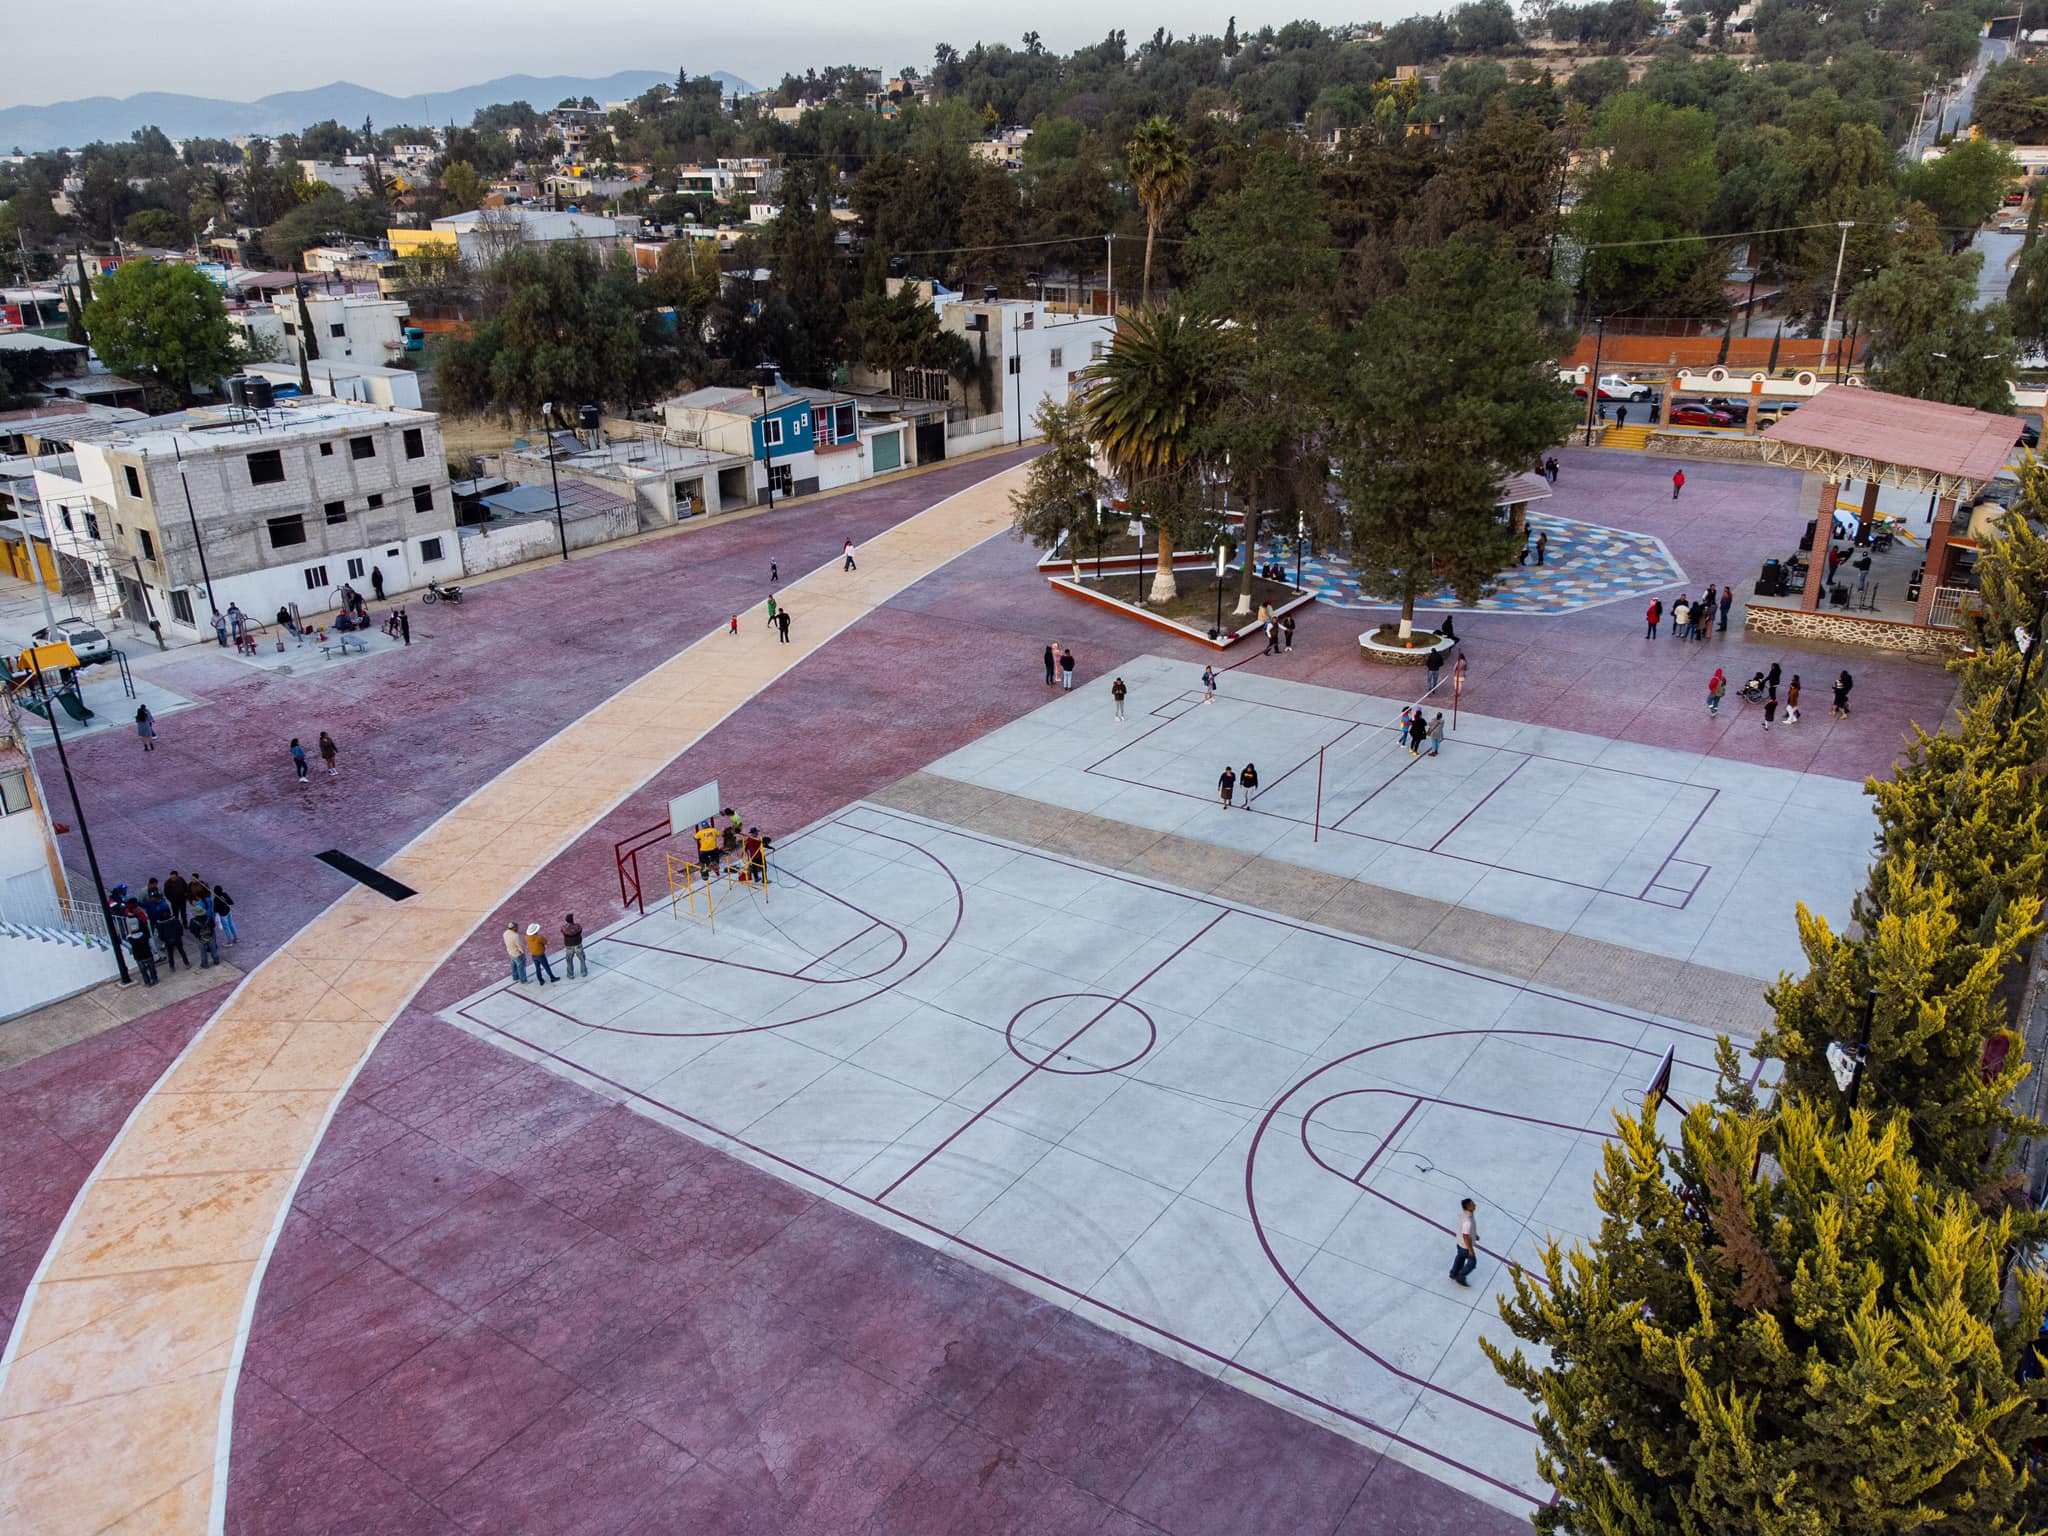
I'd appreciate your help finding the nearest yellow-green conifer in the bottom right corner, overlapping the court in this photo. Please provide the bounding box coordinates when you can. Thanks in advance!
[1483,1089,2048,1536]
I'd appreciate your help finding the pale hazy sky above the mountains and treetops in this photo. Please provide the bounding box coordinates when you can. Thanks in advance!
[0,0,1409,106]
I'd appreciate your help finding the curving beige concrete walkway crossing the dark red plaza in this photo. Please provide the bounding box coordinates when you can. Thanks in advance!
[0,469,1024,1536]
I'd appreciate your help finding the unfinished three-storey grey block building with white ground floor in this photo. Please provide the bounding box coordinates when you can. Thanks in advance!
[35,397,461,639]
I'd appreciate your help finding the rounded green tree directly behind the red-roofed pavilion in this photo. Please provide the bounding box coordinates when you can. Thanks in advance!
[1847,252,2017,412]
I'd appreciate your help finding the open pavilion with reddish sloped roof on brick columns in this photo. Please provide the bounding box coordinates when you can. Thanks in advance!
[1761,385,2025,629]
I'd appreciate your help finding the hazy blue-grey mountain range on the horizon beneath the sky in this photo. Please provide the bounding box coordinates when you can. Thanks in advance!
[0,70,754,152]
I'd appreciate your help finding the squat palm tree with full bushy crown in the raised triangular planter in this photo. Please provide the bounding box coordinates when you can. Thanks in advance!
[1087,307,1227,602]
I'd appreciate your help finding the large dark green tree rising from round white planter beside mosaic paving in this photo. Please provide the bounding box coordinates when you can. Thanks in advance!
[1335,240,1577,639]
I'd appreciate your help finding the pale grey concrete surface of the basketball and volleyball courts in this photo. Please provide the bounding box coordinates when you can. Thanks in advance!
[444,657,1870,1513]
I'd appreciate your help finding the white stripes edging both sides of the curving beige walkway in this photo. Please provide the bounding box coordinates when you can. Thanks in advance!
[0,467,1018,1536]
